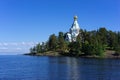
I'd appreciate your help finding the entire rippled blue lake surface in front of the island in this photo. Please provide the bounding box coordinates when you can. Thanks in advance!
[0,55,120,80]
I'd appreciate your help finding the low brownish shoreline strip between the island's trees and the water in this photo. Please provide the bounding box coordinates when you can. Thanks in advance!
[24,50,120,59]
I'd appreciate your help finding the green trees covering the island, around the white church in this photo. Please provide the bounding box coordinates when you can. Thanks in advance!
[30,27,120,56]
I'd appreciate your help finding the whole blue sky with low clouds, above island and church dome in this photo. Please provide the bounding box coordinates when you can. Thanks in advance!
[0,0,120,52]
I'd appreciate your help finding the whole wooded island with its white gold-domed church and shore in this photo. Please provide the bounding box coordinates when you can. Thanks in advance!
[26,16,120,58]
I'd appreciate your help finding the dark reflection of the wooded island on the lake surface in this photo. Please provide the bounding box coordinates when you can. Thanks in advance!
[48,57,120,80]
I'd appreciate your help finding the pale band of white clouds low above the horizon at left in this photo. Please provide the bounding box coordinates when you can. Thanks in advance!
[0,41,38,52]
